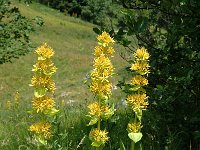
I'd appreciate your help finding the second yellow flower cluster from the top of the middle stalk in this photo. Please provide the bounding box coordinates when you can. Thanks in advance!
[94,45,115,57]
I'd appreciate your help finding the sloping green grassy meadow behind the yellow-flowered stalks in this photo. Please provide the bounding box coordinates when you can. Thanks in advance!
[0,1,127,150]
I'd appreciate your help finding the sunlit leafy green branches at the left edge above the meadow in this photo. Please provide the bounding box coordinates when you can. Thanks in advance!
[0,0,33,64]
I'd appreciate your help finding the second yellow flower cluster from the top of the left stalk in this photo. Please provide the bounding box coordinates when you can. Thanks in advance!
[32,59,57,75]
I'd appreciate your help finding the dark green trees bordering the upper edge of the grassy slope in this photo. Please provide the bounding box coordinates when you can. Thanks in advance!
[31,0,121,27]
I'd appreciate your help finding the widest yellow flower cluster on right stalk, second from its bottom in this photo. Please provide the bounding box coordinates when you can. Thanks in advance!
[126,94,149,111]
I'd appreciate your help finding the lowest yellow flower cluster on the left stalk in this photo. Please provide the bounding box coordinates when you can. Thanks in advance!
[29,122,52,139]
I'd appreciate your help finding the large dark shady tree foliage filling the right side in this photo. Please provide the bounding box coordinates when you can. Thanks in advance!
[94,0,200,150]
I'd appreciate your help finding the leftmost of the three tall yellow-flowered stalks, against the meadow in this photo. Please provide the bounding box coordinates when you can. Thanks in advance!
[29,43,58,145]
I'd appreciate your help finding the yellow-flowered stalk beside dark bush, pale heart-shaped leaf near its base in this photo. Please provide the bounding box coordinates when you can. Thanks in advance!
[126,47,149,150]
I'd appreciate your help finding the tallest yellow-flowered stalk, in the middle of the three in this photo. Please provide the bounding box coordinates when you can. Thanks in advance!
[88,32,114,149]
